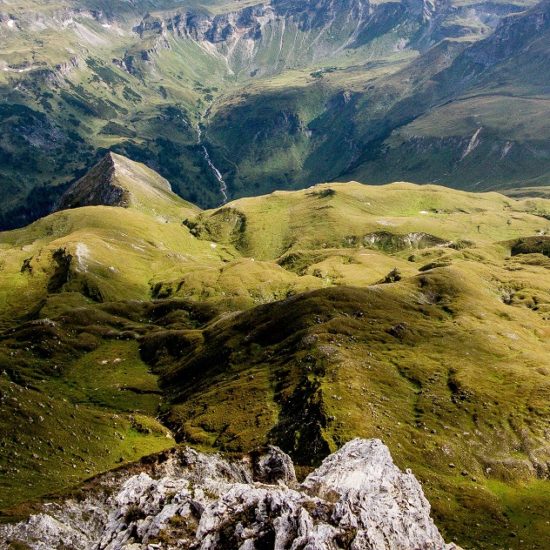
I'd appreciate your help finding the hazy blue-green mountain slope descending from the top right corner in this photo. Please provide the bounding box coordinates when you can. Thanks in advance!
[350,2,550,189]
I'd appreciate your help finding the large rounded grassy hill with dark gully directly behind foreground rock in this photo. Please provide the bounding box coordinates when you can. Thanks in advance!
[156,282,549,548]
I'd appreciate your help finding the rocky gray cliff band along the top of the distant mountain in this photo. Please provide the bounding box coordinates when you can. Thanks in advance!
[134,0,519,69]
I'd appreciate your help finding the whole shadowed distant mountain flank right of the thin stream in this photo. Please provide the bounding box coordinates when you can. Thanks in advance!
[195,3,548,201]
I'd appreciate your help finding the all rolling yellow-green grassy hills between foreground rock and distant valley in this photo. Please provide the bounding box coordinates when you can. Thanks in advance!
[0,157,550,548]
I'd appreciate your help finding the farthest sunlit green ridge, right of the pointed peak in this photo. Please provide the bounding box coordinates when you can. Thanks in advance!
[189,183,550,259]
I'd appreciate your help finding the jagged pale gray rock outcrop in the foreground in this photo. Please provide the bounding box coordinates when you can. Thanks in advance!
[0,439,457,550]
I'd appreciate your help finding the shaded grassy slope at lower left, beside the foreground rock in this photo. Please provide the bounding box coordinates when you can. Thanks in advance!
[0,336,174,514]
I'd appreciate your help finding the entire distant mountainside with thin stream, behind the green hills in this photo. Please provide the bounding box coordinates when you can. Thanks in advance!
[0,0,550,227]
